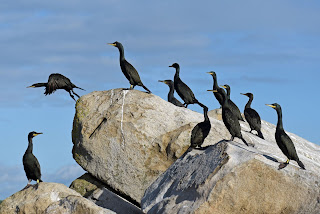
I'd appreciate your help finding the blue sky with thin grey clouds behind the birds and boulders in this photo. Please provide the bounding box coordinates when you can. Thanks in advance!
[0,0,320,199]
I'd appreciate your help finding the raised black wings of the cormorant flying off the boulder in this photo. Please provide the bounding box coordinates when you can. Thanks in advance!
[45,74,73,95]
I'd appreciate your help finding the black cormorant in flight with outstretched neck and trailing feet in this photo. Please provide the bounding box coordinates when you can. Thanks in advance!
[27,73,84,101]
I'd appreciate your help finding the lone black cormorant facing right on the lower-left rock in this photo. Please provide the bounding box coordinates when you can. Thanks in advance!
[22,131,42,187]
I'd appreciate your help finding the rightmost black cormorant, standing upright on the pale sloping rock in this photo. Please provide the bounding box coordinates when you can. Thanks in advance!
[266,103,305,169]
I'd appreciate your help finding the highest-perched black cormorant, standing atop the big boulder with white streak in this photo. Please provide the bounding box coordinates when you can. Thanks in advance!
[108,42,151,93]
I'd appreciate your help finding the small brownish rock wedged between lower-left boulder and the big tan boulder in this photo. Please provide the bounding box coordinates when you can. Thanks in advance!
[69,173,105,198]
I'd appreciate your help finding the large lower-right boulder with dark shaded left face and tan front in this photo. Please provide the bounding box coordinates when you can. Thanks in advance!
[142,139,320,214]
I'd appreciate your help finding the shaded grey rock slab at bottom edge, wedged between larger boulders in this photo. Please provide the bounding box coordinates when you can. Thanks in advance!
[89,188,143,214]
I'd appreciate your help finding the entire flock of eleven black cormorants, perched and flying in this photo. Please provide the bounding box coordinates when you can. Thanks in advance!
[23,41,305,188]
